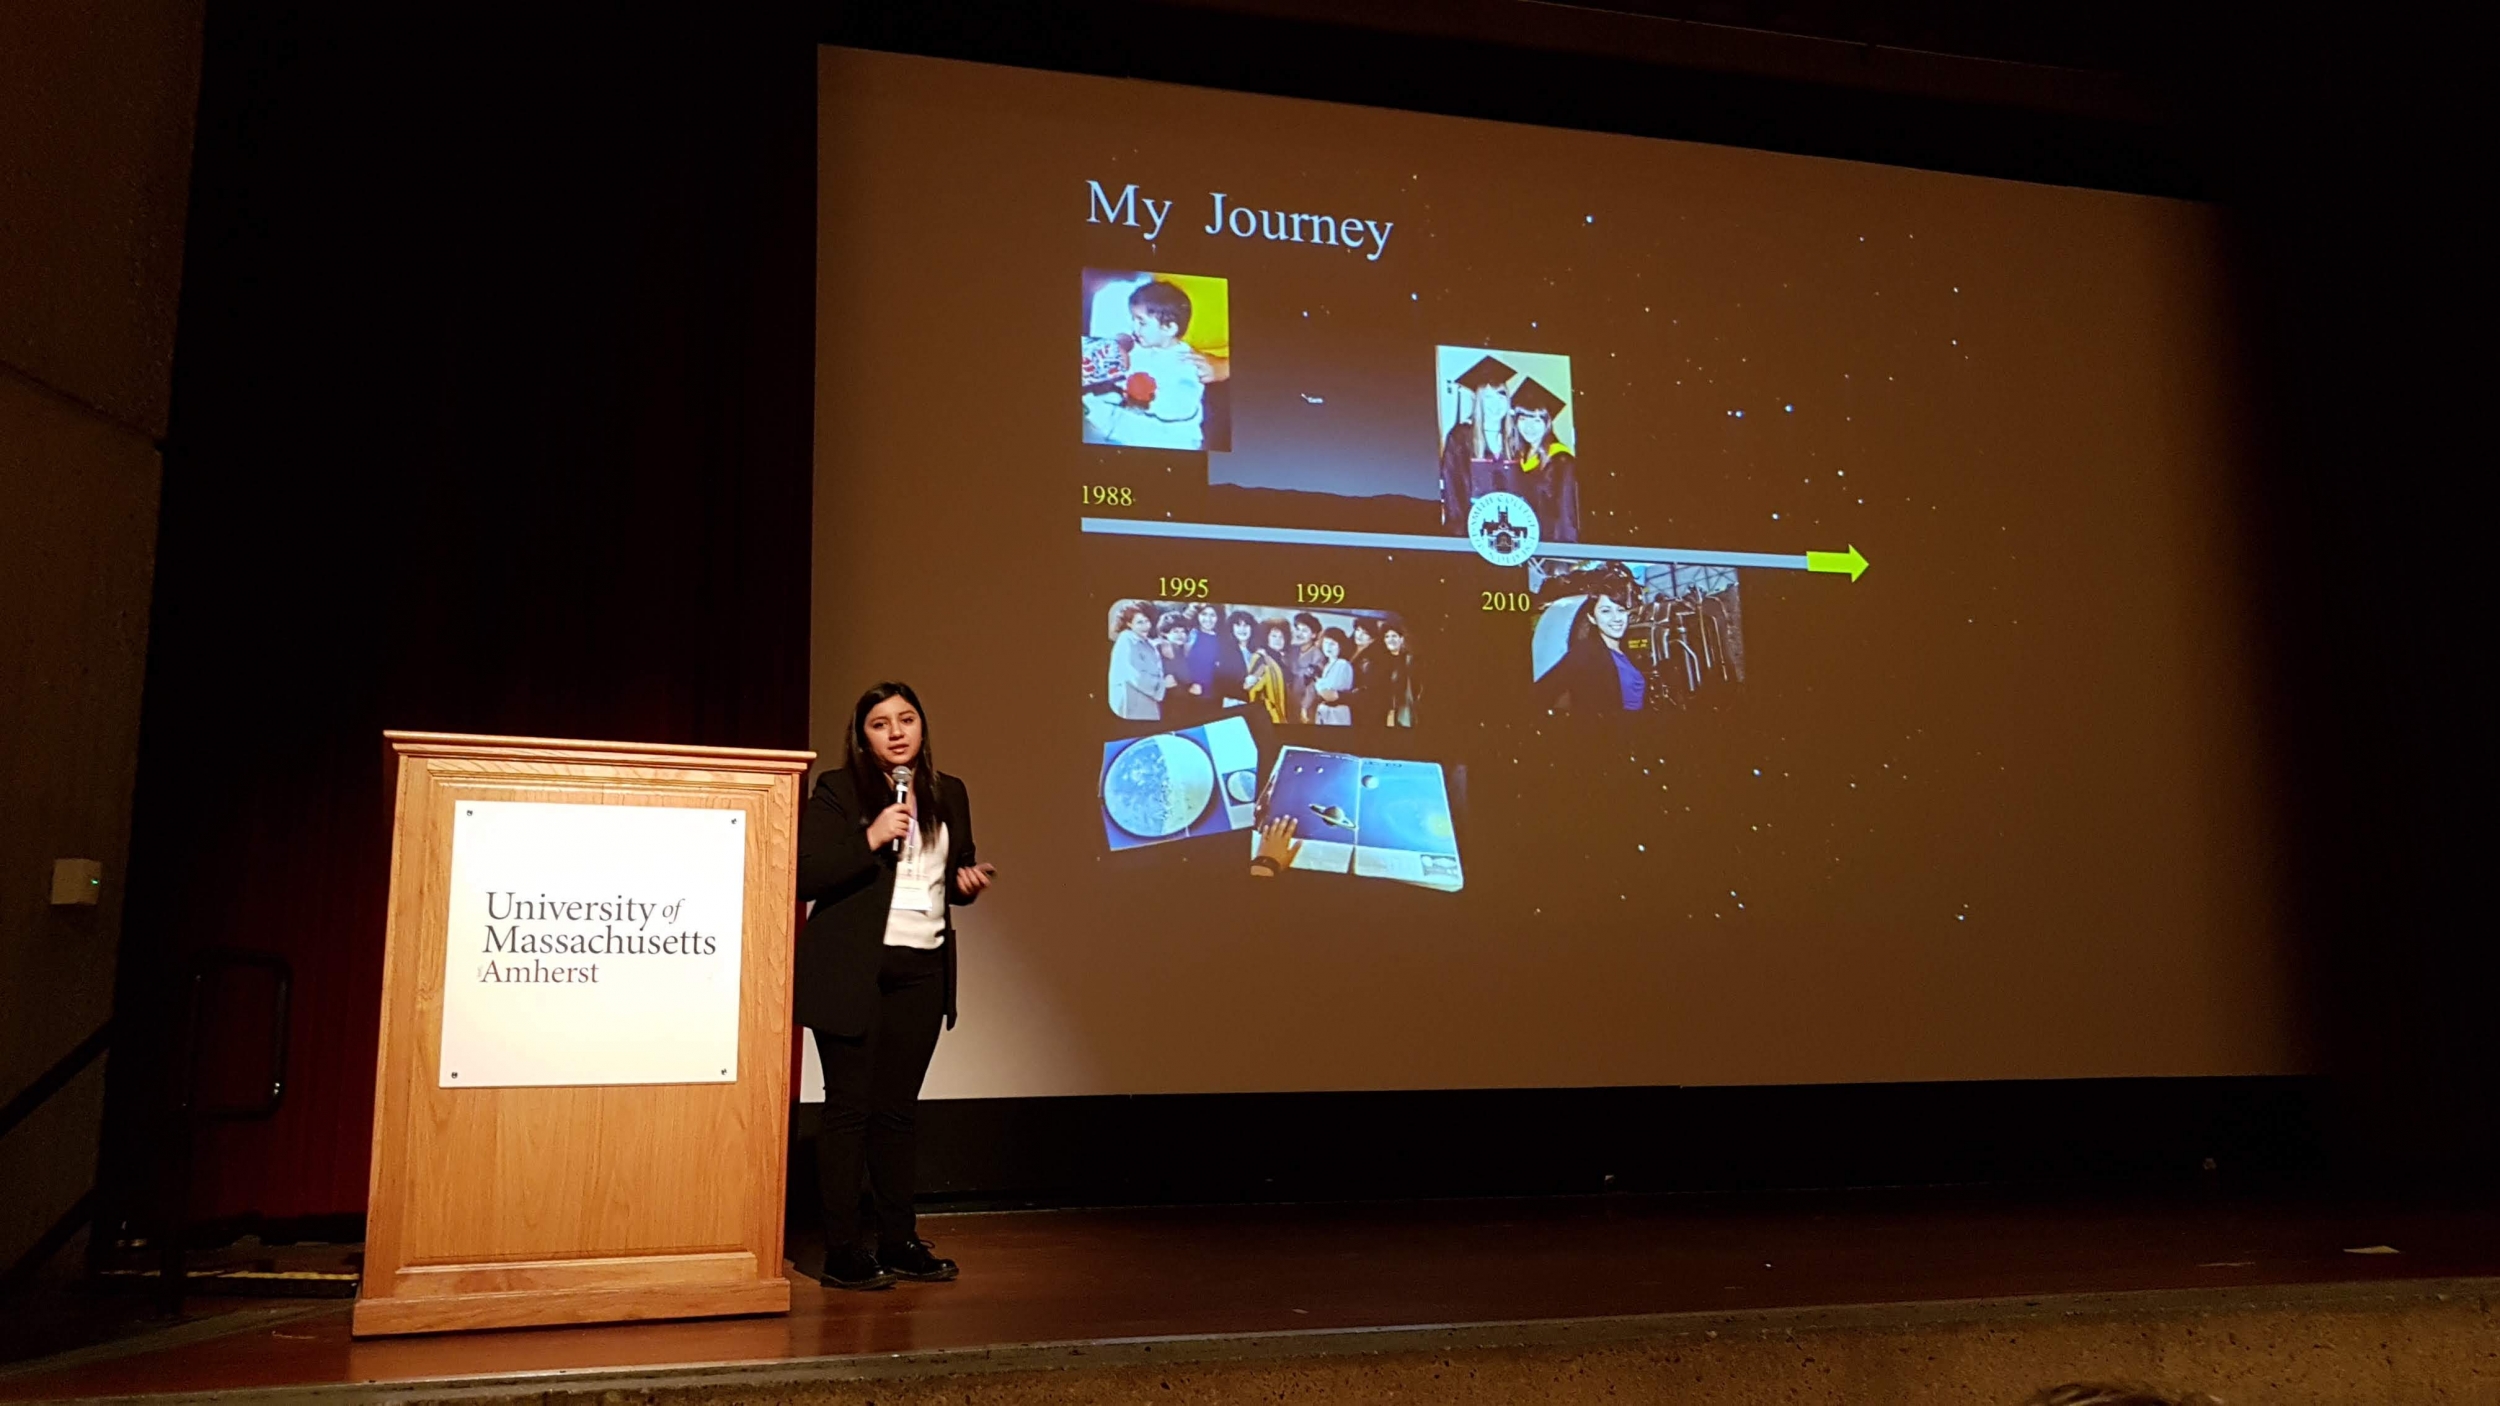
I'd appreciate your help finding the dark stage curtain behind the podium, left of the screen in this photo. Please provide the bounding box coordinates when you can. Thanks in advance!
[105,3,815,1218]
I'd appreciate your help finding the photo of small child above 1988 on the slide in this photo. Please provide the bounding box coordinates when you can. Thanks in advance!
[1078,268,1233,453]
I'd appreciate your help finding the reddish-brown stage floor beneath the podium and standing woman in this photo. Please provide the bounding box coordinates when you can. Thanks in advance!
[0,1191,2500,1401]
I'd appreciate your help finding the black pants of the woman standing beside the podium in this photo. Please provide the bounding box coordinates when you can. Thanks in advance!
[815,946,945,1251]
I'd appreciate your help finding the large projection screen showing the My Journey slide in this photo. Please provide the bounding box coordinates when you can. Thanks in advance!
[825,50,2288,1096]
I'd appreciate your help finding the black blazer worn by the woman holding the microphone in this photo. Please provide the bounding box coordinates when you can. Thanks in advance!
[793,766,975,1038]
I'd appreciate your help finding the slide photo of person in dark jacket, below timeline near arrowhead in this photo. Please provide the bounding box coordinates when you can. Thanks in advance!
[1528,558,1745,716]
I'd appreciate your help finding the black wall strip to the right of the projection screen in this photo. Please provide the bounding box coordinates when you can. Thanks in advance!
[2163,10,2500,1183]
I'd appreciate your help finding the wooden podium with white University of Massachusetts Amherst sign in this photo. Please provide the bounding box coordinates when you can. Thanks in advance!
[355,733,815,1336]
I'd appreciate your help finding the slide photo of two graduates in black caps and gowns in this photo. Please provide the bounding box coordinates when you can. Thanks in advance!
[1433,348,1580,543]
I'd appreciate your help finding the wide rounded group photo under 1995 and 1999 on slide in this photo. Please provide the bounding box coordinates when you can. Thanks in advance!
[1105,600,1423,728]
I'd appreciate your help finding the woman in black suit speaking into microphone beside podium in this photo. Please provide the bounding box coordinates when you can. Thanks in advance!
[795,683,993,1288]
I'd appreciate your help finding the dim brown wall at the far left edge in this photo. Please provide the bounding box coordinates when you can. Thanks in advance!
[0,0,200,1275]
